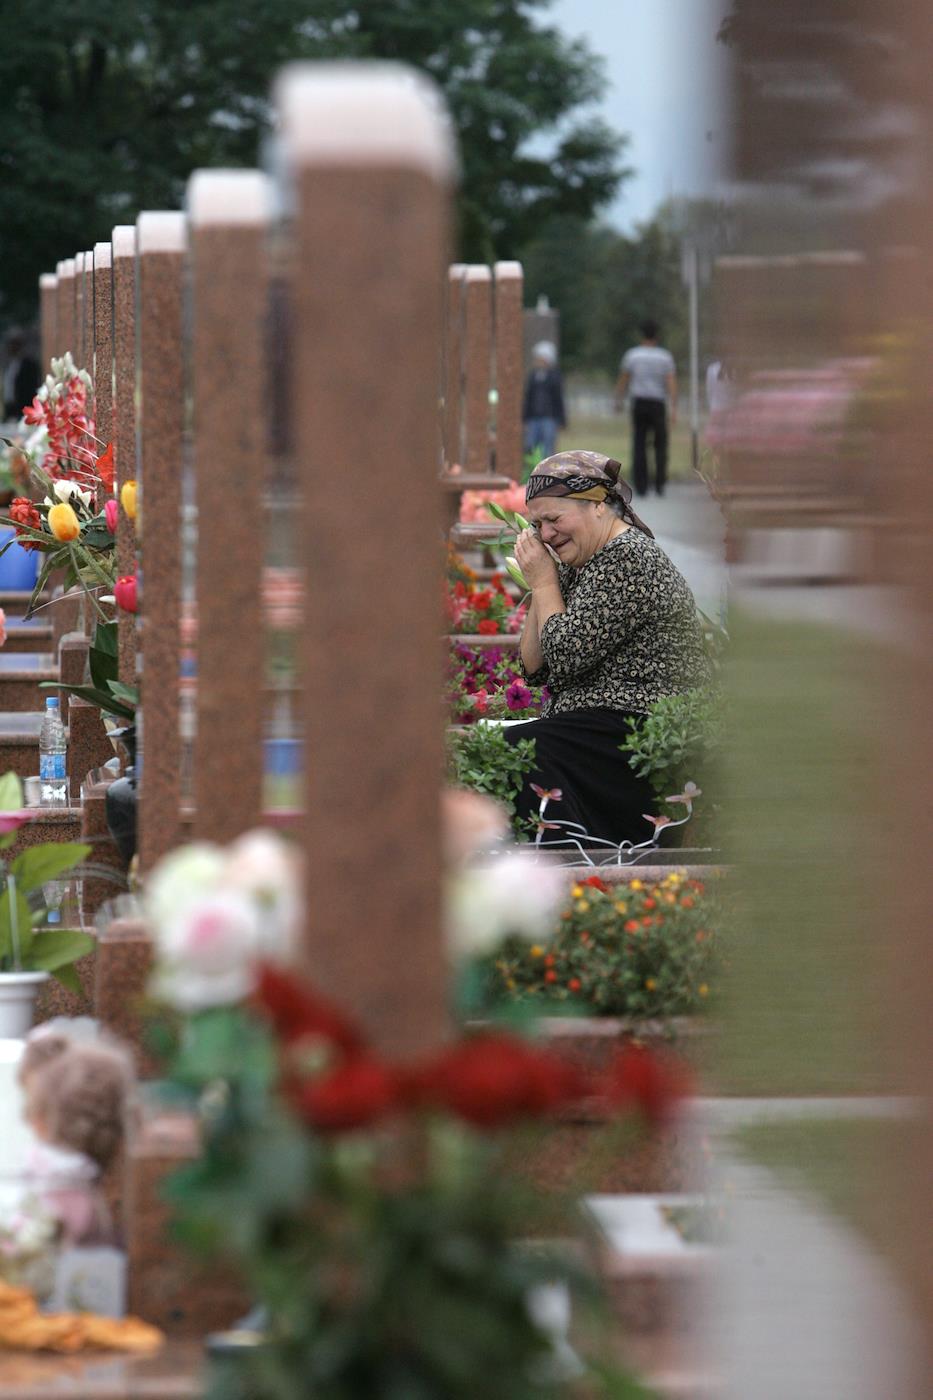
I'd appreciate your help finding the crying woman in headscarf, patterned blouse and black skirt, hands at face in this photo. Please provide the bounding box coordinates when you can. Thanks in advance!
[504,451,710,843]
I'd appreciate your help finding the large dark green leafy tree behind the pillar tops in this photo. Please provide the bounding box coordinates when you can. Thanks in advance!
[0,0,626,319]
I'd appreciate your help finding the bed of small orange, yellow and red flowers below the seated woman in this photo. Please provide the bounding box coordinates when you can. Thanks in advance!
[485,871,720,1019]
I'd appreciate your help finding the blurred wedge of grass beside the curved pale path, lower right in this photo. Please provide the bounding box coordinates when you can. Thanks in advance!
[733,1119,922,1271]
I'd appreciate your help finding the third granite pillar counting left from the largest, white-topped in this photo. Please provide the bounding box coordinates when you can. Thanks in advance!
[136,213,186,869]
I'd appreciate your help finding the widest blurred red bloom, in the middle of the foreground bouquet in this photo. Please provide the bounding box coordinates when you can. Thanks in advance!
[412,1032,586,1128]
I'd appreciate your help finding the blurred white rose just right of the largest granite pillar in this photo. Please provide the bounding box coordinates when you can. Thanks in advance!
[445,853,567,958]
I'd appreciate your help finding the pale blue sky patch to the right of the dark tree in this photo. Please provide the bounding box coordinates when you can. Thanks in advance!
[541,0,728,230]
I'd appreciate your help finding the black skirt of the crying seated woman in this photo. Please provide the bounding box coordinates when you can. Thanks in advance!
[504,710,657,844]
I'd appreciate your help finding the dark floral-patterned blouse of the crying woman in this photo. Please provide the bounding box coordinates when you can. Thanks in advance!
[521,526,710,715]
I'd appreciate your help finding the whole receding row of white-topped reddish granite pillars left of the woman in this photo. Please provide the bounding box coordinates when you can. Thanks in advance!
[35,66,456,1053]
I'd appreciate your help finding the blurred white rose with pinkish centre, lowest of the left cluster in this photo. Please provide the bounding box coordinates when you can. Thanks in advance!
[156,890,262,1011]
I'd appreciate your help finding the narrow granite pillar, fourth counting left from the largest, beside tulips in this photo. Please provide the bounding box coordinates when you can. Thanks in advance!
[111,224,136,686]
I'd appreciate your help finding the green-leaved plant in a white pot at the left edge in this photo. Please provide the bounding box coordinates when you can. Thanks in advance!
[0,773,94,1039]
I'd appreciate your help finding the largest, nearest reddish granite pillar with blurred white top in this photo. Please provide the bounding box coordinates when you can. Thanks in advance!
[277,64,452,1054]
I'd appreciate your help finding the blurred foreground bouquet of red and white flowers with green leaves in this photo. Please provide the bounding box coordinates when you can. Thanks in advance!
[146,833,678,1400]
